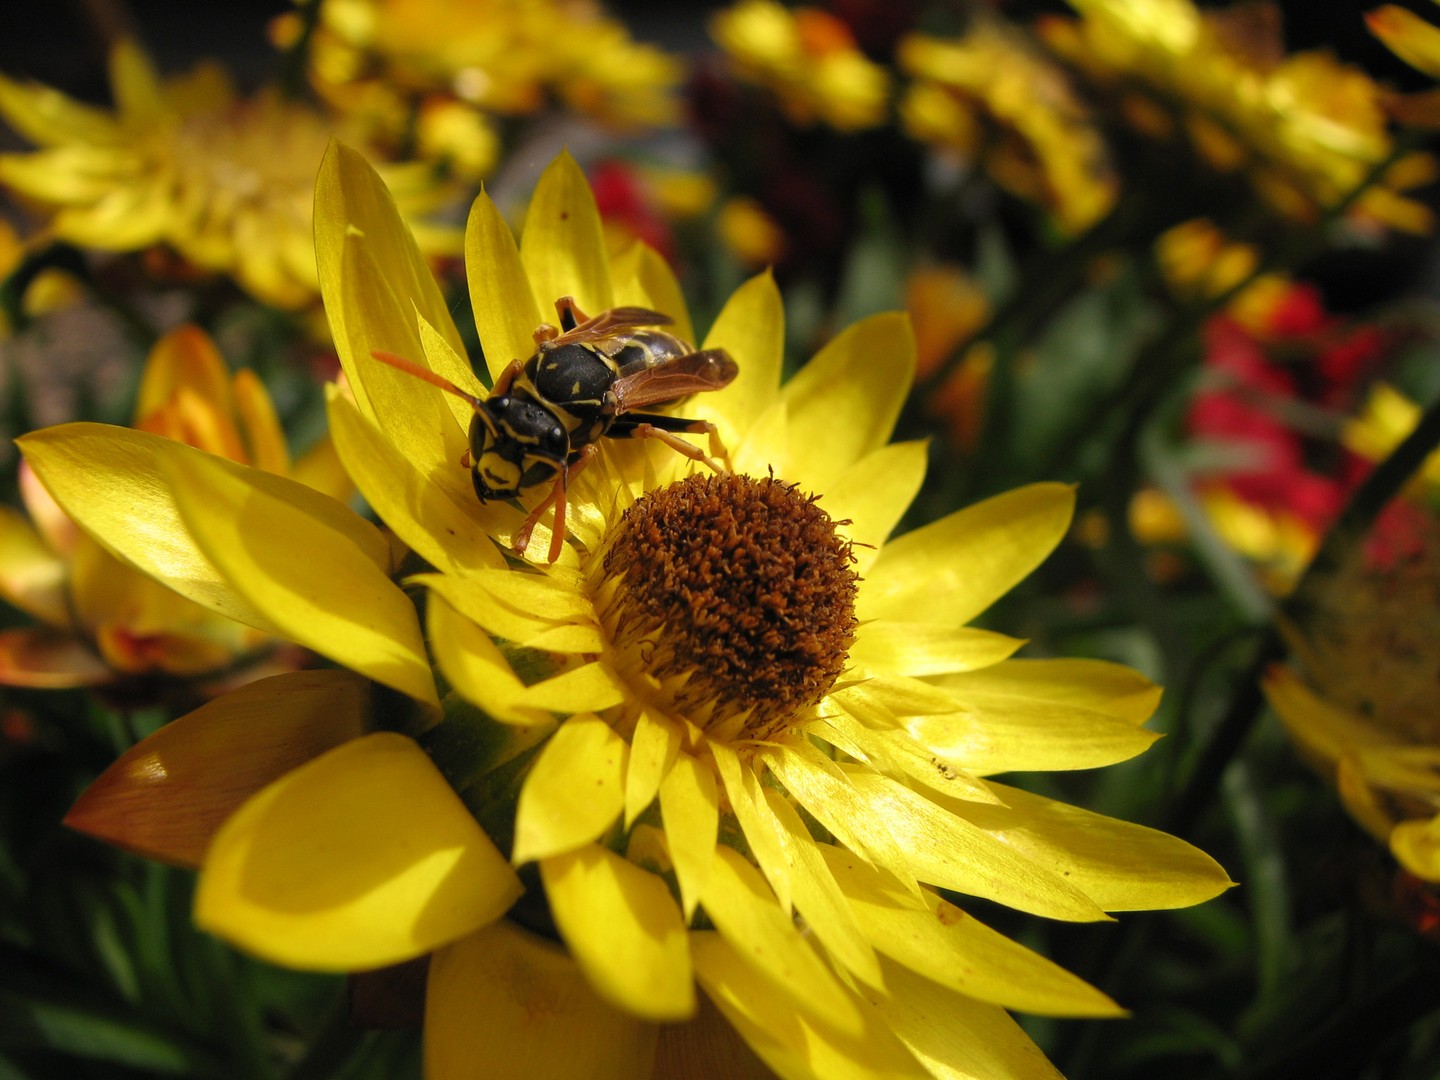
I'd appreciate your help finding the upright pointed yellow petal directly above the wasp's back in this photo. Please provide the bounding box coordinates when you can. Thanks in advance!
[520,151,615,321]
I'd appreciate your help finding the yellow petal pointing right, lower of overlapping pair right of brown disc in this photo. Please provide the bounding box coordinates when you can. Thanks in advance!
[903,688,1159,776]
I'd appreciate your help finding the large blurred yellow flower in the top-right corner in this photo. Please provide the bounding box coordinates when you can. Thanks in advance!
[1041,0,1434,233]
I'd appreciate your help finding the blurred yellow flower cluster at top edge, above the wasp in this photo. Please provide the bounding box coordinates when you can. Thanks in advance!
[286,0,680,179]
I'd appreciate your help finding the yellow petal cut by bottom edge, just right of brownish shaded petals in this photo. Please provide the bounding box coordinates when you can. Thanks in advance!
[690,932,921,1080]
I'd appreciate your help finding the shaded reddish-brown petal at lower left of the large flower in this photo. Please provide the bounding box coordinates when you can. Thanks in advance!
[65,671,369,867]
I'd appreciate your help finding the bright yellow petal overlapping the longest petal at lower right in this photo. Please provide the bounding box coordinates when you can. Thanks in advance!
[850,770,1106,923]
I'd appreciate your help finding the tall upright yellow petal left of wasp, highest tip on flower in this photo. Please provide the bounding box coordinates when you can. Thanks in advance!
[315,143,464,440]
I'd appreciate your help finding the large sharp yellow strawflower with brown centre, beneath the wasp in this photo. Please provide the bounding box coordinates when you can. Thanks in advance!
[47,147,1230,1080]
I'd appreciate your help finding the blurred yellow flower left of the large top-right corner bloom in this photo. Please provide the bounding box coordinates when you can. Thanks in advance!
[899,22,1117,233]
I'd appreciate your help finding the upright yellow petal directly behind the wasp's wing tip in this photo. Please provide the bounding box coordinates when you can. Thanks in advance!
[694,271,785,449]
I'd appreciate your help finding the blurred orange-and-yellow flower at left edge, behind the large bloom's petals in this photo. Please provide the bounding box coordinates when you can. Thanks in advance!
[0,325,350,687]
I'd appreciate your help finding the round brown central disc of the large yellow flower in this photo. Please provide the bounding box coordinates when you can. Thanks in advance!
[596,474,858,737]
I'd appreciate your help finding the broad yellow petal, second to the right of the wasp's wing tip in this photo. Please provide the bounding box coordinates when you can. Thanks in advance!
[780,312,914,491]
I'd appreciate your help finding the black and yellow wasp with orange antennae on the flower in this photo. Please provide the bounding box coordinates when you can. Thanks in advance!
[372,297,740,563]
